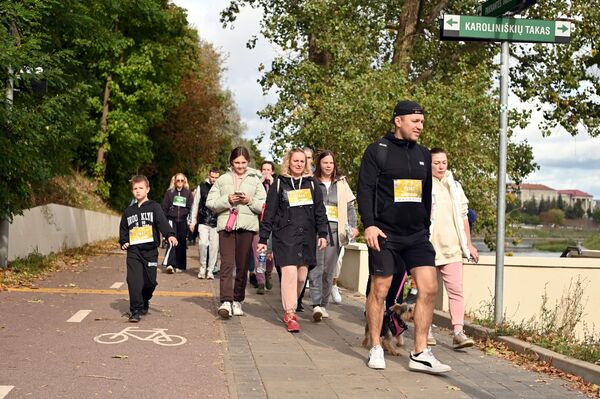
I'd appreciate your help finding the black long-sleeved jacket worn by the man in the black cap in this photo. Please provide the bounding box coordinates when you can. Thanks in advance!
[357,133,431,236]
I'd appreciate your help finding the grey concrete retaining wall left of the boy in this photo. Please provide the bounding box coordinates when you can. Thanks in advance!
[8,204,120,261]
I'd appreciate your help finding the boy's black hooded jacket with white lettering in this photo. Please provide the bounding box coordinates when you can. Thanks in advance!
[119,200,175,251]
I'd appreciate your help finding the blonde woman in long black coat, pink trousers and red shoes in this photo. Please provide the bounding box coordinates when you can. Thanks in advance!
[256,148,327,332]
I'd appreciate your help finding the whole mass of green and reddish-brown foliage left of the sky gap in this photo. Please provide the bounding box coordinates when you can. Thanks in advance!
[0,0,244,219]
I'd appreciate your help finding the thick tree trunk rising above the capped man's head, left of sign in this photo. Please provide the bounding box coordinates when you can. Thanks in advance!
[392,0,422,75]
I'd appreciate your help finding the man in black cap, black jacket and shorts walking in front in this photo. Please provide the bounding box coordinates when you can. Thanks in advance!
[357,100,451,374]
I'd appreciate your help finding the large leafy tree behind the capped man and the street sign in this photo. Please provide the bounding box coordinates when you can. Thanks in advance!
[222,0,598,244]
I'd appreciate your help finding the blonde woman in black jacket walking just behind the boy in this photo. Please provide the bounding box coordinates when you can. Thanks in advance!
[162,173,194,274]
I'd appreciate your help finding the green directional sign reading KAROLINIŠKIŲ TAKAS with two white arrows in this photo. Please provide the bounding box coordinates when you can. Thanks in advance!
[440,15,571,43]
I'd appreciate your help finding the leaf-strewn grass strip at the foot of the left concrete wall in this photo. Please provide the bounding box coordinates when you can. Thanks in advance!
[0,238,119,290]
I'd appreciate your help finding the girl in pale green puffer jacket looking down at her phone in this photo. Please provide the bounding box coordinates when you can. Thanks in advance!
[206,147,267,318]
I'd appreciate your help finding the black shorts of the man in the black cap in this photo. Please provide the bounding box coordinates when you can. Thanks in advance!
[369,231,435,276]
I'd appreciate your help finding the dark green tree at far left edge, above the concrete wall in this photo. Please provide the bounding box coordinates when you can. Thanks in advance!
[0,0,85,220]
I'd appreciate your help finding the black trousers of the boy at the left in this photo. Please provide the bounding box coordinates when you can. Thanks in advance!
[127,249,158,314]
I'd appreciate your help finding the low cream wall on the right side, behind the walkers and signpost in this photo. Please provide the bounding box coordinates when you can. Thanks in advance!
[339,250,600,337]
